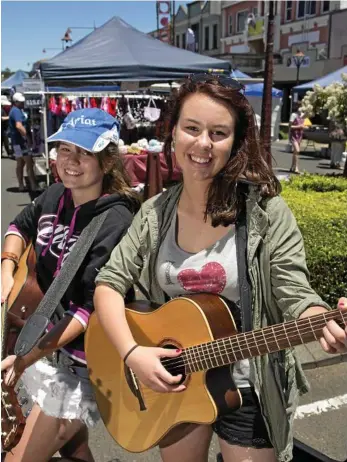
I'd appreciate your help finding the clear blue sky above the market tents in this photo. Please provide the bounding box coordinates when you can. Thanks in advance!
[1,0,187,71]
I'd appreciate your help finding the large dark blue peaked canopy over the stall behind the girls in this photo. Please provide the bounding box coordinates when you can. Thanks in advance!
[40,16,230,84]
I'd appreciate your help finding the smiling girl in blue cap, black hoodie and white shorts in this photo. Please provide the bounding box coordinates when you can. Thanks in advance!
[1,109,138,462]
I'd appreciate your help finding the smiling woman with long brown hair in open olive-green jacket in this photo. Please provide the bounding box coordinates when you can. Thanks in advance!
[94,74,347,462]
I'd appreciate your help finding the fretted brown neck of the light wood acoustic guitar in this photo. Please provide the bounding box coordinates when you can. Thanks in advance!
[182,310,347,373]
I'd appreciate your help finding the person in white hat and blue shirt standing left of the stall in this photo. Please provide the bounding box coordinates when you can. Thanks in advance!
[9,93,39,192]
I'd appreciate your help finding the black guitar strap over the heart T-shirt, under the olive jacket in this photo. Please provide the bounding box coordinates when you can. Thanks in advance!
[236,185,253,332]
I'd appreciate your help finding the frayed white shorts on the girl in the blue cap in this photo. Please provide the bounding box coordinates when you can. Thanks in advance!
[21,358,100,427]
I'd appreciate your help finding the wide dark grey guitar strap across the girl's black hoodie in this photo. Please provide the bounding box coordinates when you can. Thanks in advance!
[14,210,108,356]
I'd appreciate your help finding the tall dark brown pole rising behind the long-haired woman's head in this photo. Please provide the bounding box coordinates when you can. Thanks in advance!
[260,1,275,166]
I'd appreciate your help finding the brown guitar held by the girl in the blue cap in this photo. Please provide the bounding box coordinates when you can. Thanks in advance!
[1,244,43,452]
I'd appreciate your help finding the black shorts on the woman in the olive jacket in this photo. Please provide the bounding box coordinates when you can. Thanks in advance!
[212,388,273,449]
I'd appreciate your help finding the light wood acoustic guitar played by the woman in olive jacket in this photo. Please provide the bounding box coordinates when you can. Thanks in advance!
[85,294,347,452]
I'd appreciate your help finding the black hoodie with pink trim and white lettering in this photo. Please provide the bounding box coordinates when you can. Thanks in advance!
[5,184,136,364]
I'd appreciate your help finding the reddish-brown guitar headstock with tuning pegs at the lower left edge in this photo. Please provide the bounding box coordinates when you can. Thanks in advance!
[1,374,25,452]
